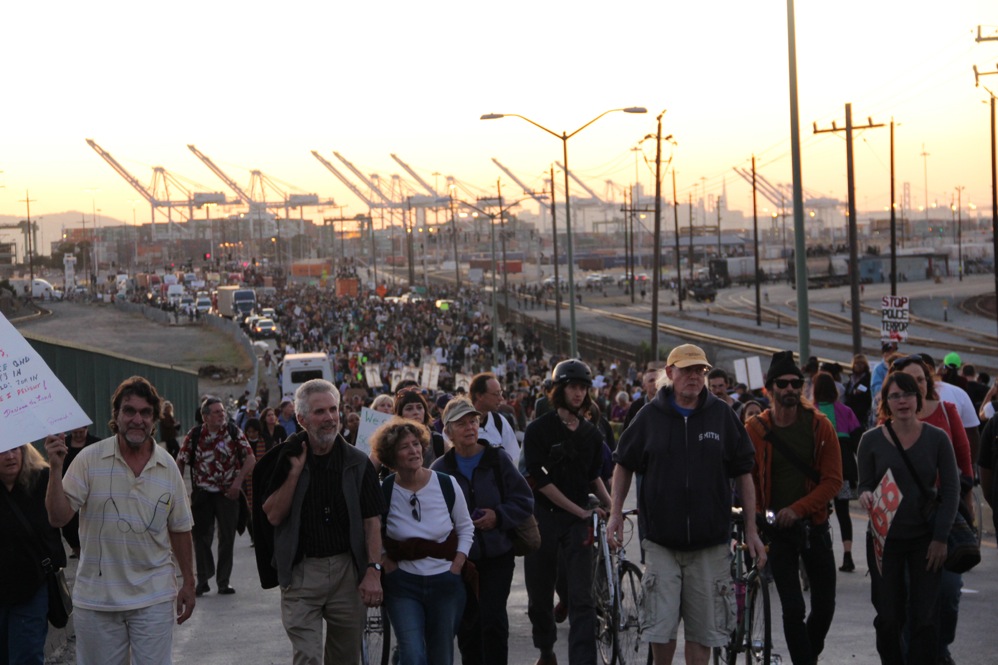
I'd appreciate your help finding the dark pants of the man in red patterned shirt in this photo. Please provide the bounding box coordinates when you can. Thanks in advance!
[191,489,239,589]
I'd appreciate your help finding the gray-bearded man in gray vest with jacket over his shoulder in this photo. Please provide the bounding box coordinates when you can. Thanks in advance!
[263,379,386,665]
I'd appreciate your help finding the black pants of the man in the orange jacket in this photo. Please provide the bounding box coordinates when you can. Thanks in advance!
[769,522,835,665]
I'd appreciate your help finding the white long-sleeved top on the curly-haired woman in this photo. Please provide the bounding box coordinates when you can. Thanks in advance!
[385,472,475,576]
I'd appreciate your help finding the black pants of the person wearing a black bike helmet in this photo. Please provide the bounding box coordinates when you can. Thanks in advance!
[523,507,596,665]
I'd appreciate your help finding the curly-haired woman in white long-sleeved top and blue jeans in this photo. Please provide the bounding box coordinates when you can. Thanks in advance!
[371,418,474,665]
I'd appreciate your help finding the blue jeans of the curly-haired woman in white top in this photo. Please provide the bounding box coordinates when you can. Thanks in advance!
[381,570,465,665]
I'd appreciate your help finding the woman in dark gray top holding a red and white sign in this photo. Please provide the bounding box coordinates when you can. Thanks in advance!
[858,372,960,665]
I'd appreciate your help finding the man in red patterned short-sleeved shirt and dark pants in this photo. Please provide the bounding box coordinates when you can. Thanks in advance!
[177,397,256,596]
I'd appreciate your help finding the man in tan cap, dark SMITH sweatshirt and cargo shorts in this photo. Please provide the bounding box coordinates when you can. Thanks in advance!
[607,344,766,665]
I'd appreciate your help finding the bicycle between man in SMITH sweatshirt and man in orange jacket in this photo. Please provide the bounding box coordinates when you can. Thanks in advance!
[713,508,783,665]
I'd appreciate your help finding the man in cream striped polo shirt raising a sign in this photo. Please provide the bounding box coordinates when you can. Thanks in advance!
[45,376,194,665]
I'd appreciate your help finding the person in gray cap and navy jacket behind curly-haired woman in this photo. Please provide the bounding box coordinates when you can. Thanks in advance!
[431,397,534,665]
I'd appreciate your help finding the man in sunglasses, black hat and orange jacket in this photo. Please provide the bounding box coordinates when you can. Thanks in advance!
[745,351,842,665]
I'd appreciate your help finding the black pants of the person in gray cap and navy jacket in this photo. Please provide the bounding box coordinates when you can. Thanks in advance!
[457,550,516,665]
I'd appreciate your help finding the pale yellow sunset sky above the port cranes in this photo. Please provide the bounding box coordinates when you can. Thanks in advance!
[0,0,998,247]
